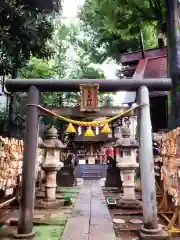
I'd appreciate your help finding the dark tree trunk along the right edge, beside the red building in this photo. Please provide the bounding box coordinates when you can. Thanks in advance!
[166,0,180,129]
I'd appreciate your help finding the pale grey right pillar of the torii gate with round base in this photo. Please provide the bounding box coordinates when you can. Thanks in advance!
[138,86,167,239]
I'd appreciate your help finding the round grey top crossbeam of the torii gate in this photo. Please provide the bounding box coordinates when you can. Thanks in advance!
[6,78,171,92]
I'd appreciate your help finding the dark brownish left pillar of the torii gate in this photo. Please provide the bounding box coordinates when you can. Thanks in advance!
[15,86,40,239]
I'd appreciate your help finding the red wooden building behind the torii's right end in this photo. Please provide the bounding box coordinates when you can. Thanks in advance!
[119,47,168,132]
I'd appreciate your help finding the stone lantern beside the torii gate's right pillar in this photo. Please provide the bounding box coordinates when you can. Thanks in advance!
[114,127,140,208]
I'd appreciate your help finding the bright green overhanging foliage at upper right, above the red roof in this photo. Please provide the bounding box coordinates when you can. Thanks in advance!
[79,0,165,62]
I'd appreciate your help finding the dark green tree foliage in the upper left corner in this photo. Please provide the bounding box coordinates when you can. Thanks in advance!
[0,0,53,75]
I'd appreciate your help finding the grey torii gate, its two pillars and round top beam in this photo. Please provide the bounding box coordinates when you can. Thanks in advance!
[5,78,172,239]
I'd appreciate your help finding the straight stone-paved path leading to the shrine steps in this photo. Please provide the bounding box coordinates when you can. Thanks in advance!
[61,180,116,240]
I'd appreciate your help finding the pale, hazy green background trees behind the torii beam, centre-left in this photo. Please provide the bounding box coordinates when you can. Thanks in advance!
[13,17,113,129]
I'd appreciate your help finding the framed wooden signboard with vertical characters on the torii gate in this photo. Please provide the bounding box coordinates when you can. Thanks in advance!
[80,84,99,112]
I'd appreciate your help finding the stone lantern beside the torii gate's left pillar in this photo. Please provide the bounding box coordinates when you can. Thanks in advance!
[42,126,66,201]
